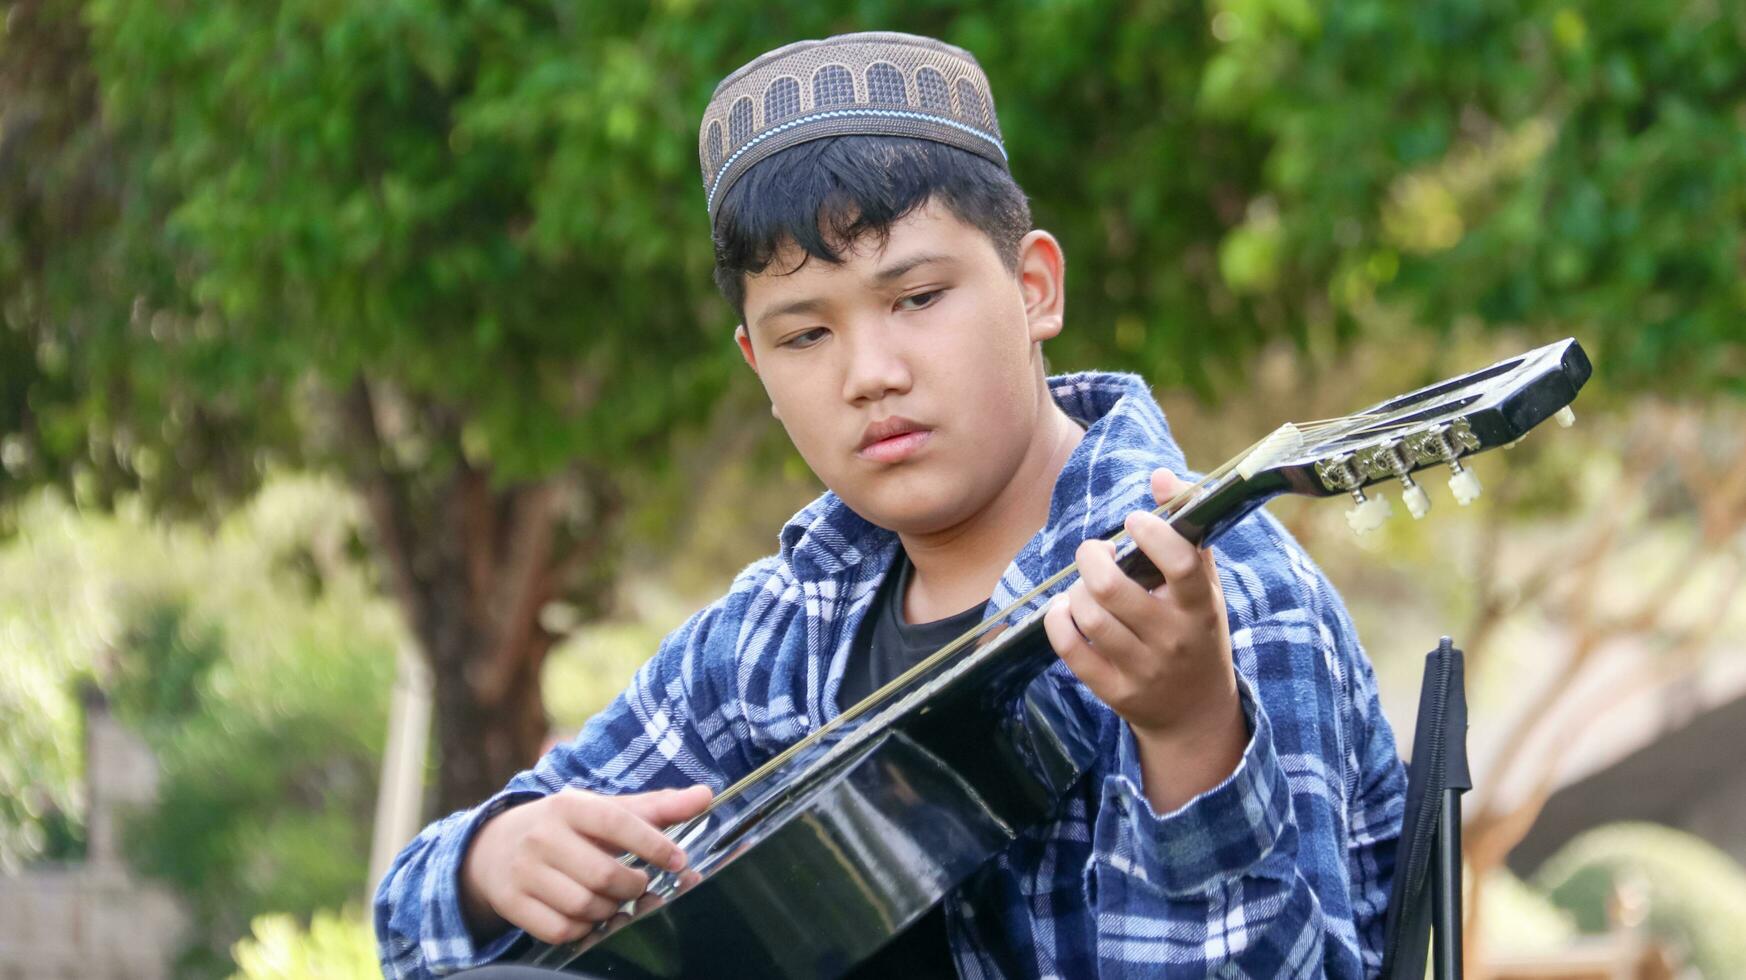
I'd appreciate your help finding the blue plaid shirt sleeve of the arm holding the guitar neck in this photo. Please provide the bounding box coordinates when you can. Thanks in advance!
[1084,531,1404,977]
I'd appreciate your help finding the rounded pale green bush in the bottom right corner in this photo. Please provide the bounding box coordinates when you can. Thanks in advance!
[1535,823,1746,977]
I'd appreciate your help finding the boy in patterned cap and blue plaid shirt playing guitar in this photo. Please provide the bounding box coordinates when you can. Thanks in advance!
[375,33,1404,977]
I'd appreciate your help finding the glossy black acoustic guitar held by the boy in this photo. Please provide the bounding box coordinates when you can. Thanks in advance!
[471,339,1592,980]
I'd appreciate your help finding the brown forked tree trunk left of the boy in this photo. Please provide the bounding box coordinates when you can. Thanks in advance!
[346,381,620,814]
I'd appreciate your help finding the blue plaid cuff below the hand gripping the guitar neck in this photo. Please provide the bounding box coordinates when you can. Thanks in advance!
[1091,674,1292,896]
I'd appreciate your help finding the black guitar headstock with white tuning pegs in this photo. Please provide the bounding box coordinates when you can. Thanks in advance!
[1236,339,1594,533]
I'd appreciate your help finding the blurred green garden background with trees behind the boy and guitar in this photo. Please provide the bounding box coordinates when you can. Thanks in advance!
[0,0,1746,977]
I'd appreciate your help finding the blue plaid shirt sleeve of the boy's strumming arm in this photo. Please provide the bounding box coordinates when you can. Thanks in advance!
[374,566,771,980]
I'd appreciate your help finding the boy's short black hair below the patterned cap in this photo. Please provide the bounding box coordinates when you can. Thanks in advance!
[714,136,1030,318]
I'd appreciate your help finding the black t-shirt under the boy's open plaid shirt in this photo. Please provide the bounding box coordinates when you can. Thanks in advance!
[836,547,983,980]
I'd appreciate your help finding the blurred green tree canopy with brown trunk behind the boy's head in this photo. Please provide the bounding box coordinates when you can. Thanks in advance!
[0,0,1746,805]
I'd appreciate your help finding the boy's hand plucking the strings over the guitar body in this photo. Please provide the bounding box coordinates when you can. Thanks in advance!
[461,786,712,943]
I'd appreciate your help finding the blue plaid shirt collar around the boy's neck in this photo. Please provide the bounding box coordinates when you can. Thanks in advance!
[780,370,1186,582]
